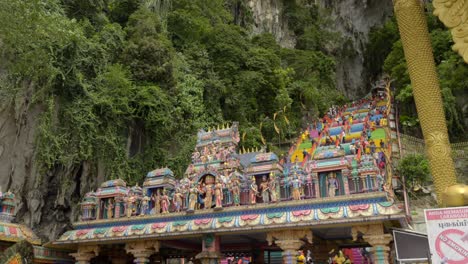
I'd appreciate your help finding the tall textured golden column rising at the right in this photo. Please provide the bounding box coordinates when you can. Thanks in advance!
[394,0,460,204]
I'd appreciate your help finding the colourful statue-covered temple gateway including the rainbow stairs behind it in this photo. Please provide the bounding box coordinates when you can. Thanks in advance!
[54,83,408,264]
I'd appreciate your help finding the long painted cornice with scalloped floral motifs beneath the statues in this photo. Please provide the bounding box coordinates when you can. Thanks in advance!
[55,192,407,244]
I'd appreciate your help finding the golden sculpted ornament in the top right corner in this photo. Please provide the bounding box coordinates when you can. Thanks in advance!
[432,0,468,63]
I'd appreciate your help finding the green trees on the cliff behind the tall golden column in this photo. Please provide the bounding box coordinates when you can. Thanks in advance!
[367,5,468,141]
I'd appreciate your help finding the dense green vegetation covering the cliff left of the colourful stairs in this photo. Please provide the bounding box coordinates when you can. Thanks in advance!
[0,0,344,183]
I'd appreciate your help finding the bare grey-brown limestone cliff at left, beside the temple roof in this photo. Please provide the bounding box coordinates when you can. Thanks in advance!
[0,89,104,241]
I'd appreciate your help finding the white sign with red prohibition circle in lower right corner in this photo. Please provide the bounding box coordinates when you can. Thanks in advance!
[424,207,468,264]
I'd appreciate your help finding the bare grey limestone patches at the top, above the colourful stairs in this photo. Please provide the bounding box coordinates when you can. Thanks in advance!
[248,0,393,98]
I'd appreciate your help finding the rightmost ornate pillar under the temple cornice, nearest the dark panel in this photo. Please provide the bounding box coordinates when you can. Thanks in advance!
[351,223,393,264]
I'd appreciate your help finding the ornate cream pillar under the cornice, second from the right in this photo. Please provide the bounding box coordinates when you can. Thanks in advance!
[267,229,312,264]
